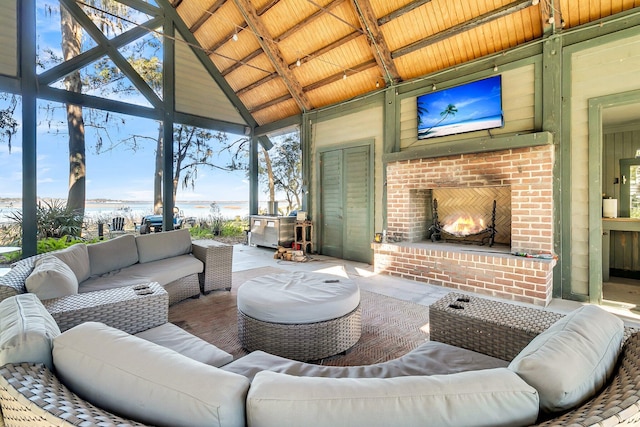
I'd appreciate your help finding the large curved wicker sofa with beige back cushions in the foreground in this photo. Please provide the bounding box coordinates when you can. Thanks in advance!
[0,292,640,427]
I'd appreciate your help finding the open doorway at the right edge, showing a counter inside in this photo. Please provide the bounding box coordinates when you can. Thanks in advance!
[589,91,640,314]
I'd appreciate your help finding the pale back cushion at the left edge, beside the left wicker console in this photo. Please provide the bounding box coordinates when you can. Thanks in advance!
[0,294,60,370]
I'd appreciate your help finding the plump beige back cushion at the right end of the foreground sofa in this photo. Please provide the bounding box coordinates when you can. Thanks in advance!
[509,305,624,412]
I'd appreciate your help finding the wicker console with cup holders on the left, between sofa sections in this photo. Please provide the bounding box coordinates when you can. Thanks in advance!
[43,282,169,334]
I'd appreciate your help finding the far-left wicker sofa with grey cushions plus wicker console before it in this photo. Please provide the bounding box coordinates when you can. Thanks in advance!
[0,229,222,333]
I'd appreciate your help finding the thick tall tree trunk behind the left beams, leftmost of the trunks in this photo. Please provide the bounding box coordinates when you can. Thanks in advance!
[60,7,87,216]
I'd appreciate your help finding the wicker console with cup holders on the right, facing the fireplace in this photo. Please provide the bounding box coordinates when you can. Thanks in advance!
[429,292,563,361]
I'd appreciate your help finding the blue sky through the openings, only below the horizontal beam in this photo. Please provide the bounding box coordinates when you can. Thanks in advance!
[0,101,249,201]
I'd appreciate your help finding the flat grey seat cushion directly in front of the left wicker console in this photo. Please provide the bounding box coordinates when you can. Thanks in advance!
[136,323,233,366]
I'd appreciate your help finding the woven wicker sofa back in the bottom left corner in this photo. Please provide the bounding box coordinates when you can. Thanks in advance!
[0,363,143,427]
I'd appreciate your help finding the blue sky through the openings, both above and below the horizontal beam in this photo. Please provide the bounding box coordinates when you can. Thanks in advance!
[0,0,255,201]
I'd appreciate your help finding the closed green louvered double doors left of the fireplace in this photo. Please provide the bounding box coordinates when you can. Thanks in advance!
[319,142,373,264]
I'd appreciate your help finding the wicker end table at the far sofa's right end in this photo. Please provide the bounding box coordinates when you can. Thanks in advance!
[191,240,233,294]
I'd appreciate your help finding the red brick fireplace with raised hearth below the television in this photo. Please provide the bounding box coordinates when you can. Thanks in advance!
[373,145,555,306]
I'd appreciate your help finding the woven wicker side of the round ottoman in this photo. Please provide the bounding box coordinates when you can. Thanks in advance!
[238,305,362,361]
